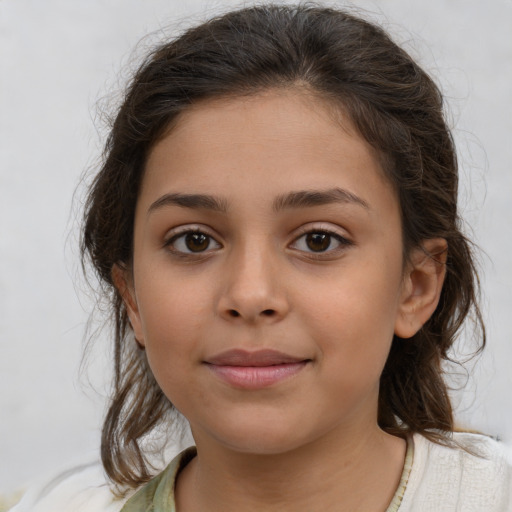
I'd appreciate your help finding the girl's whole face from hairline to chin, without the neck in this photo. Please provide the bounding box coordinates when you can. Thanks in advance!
[125,91,412,453]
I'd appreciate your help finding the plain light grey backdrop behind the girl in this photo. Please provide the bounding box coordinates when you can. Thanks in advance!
[0,0,512,490]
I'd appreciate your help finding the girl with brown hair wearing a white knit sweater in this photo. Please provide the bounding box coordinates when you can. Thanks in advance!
[9,5,512,512]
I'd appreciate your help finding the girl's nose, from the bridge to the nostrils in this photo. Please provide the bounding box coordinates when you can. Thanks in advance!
[218,246,289,324]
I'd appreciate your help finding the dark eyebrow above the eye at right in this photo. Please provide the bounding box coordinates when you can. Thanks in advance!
[273,188,370,212]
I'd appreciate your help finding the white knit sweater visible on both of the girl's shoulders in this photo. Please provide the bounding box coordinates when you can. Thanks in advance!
[11,433,512,512]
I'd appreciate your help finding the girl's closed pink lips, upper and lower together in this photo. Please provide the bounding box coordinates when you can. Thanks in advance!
[204,349,311,389]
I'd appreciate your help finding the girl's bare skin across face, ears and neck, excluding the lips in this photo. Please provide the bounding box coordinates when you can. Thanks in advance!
[114,90,446,512]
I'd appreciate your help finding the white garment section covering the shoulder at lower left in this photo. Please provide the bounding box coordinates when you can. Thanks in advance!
[11,463,132,512]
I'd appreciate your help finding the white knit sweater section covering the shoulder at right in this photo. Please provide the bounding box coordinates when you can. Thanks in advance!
[400,433,512,512]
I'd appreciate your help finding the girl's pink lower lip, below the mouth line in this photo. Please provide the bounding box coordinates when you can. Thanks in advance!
[208,361,307,389]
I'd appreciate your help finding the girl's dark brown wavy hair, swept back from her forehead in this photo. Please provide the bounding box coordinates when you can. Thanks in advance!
[82,5,485,487]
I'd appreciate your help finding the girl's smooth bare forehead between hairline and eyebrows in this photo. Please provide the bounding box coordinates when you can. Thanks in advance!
[140,90,400,218]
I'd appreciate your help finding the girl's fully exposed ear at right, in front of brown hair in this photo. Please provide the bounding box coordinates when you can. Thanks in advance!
[395,238,448,338]
